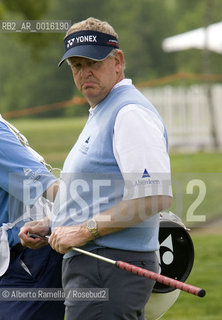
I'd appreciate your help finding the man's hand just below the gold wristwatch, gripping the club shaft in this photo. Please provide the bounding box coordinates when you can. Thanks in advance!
[49,224,93,254]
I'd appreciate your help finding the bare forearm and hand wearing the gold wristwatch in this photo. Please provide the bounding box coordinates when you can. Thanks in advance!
[49,196,172,253]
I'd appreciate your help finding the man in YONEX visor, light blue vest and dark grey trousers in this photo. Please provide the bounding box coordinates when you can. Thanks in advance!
[20,18,172,320]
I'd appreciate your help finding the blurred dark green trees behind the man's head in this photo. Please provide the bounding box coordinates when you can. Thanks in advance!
[0,0,222,117]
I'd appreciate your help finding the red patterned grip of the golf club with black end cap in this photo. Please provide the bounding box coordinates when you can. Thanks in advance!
[116,261,206,297]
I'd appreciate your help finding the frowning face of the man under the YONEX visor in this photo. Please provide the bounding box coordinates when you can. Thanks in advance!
[69,52,123,107]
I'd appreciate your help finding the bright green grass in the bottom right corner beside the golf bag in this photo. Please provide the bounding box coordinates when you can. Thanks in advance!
[151,235,222,320]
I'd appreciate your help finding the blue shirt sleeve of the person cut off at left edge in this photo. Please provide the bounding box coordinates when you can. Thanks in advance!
[0,122,57,205]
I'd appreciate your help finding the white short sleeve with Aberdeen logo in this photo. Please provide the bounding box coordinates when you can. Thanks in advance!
[113,104,172,200]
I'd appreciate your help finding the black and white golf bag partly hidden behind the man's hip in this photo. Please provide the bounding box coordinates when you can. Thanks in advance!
[146,212,194,320]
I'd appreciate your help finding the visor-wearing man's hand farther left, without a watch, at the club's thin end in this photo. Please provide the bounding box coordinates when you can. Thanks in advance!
[19,218,49,249]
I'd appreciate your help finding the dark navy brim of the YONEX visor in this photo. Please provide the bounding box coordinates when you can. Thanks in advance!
[58,45,113,67]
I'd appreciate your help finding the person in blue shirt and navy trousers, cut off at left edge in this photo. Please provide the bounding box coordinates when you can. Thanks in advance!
[0,116,64,320]
